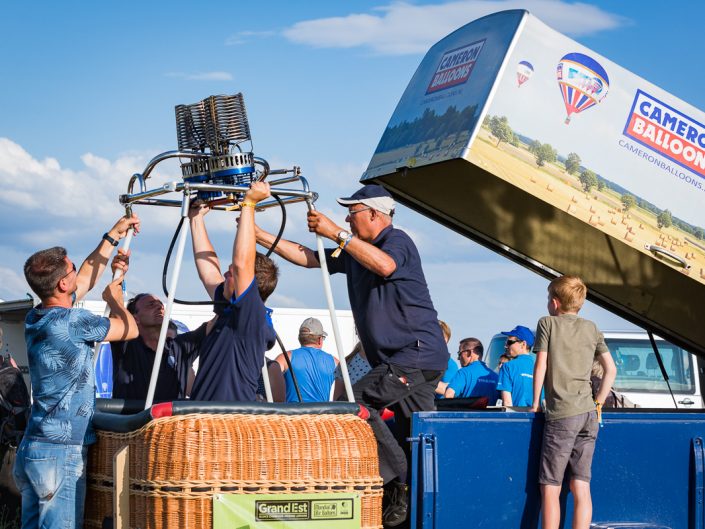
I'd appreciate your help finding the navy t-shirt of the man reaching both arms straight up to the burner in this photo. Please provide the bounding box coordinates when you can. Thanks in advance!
[191,279,276,402]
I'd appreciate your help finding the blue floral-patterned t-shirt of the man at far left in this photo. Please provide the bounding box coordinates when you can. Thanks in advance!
[25,305,110,445]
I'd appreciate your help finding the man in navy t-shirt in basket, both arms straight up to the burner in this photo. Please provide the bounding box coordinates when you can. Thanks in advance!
[189,182,279,402]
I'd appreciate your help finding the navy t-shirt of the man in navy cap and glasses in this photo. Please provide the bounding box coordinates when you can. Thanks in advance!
[326,226,449,371]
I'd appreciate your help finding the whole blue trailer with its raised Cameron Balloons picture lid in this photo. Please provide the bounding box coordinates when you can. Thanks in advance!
[362,10,705,528]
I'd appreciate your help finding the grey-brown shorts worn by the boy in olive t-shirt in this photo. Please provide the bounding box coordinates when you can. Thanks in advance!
[539,411,599,486]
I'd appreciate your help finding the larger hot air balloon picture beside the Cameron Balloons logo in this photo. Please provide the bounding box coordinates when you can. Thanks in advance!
[556,53,610,125]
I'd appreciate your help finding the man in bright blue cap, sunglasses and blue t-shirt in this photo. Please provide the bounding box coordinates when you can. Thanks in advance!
[497,325,536,407]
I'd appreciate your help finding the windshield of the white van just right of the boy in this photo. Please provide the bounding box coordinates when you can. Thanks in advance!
[605,338,695,393]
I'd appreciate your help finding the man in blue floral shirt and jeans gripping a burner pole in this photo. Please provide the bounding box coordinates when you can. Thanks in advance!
[14,213,139,529]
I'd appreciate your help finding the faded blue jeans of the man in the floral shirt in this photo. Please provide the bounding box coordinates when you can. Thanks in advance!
[14,439,88,529]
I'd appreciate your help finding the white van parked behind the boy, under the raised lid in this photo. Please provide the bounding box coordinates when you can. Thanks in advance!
[484,331,705,409]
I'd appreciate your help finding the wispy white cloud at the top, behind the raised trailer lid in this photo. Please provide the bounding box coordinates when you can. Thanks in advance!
[283,0,626,55]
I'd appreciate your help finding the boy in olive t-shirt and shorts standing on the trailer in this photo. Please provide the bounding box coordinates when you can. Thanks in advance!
[531,276,617,529]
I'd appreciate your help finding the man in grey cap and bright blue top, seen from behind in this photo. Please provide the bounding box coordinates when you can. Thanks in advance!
[277,318,338,402]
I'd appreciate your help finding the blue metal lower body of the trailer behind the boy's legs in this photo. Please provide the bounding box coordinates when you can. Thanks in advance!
[411,409,705,529]
